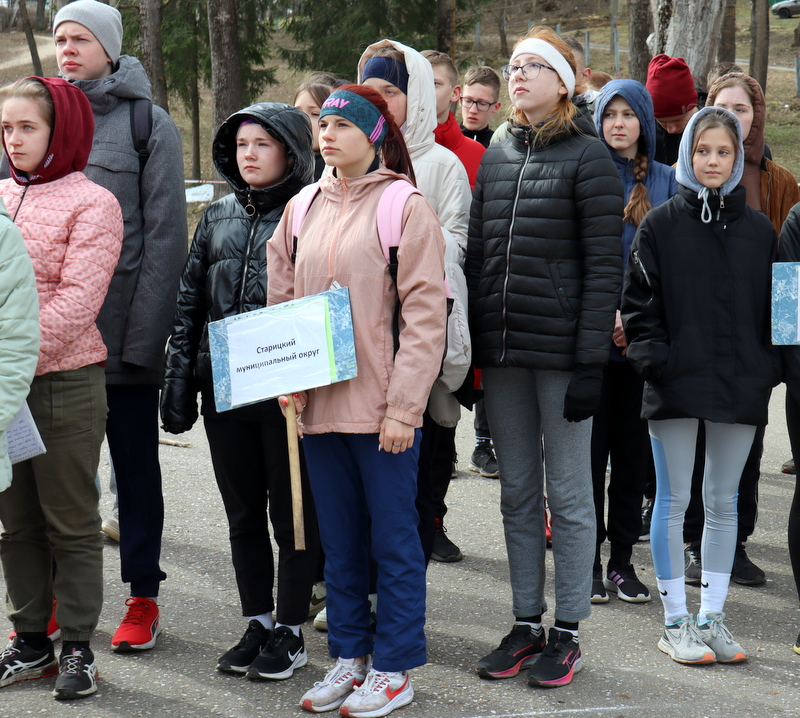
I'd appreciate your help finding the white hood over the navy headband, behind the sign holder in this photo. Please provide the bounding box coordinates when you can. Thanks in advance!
[358,40,438,160]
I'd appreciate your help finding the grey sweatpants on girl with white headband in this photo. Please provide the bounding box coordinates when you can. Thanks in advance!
[483,368,596,621]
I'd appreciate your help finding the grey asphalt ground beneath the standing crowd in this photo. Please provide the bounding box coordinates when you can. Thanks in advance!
[0,387,800,718]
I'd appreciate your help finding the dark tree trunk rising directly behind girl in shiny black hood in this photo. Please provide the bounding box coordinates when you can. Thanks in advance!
[207,0,239,198]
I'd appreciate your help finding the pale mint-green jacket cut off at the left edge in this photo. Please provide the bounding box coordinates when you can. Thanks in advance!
[0,197,39,491]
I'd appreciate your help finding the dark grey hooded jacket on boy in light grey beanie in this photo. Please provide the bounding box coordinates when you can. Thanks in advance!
[74,55,189,384]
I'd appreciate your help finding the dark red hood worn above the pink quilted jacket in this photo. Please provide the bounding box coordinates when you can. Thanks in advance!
[3,77,94,185]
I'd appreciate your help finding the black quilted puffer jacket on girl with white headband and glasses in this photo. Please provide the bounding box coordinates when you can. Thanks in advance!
[466,116,623,371]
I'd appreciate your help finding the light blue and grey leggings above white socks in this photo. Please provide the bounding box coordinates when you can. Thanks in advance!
[648,419,756,581]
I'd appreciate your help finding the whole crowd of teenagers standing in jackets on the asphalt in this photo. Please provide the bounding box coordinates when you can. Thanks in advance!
[0,0,800,718]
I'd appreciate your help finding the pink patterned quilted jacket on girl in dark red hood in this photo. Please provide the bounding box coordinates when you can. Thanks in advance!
[0,172,123,376]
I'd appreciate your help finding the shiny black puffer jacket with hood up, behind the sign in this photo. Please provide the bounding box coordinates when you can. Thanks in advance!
[161,102,314,434]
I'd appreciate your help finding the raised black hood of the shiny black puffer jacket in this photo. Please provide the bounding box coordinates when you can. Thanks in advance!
[211,102,314,211]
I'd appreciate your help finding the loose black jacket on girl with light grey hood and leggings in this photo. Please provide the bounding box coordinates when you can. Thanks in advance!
[622,185,781,425]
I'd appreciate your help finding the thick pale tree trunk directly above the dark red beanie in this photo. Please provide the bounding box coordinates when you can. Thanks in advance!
[664,0,724,89]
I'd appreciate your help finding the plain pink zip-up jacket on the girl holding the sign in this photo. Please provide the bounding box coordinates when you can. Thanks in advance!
[267,165,447,434]
